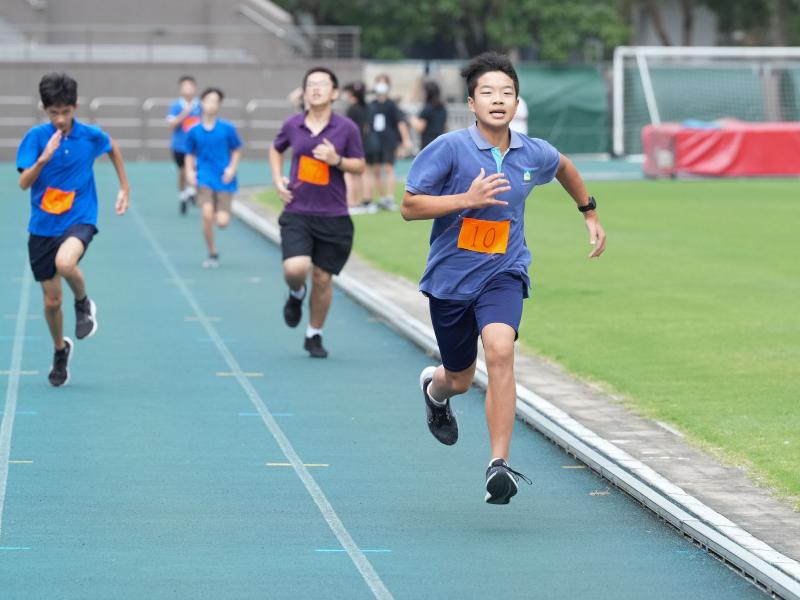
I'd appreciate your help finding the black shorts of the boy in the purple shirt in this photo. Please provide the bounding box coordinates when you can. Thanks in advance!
[278,211,353,275]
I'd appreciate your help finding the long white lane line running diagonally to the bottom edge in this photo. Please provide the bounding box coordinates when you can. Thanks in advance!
[130,209,393,600]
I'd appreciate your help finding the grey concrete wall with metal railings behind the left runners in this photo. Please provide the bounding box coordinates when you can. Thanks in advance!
[0,60,363,160]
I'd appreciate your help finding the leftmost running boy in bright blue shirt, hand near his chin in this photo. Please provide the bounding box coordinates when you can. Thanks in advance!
[17,73,129,387]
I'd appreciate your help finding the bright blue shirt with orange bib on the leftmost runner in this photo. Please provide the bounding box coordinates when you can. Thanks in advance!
[17,120,111,237]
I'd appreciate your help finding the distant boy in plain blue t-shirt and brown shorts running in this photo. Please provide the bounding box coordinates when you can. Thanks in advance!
[186,88,242,269]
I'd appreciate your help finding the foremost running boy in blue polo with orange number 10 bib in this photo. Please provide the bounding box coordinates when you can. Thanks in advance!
[401,53,605,504]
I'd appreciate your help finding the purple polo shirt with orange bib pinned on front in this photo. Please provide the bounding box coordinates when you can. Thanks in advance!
[272,113,364,217]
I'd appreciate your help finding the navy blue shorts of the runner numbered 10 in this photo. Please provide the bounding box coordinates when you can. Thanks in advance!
[428,273,527,373]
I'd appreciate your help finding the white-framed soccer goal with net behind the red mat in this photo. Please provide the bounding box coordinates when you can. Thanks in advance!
[613,46,800,155]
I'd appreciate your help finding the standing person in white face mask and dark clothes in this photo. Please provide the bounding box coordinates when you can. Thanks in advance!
[364,74,411,210]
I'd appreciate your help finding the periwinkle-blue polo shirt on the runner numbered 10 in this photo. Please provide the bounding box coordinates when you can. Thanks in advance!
[406,125,561,300]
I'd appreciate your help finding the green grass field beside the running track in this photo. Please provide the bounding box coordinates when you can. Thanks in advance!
[264,180,800,509]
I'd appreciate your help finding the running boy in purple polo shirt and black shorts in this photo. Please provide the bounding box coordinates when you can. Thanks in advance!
[269,67,365,358]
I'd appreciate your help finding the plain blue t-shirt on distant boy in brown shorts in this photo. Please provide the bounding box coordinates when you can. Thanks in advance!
[186,119,242,193]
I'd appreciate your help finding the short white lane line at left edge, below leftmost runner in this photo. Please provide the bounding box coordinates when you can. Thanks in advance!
[0,262,31,536]
